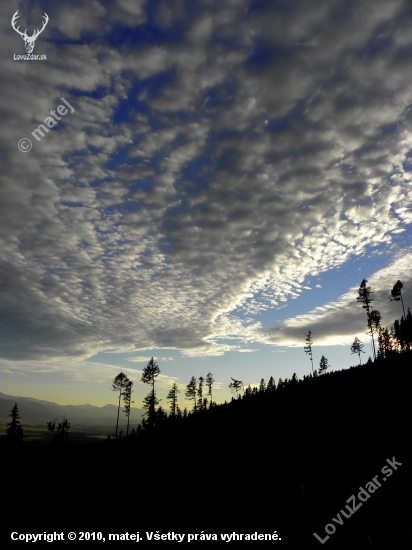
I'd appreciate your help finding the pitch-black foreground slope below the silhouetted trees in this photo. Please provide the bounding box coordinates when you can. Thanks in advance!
[1,355,412,548]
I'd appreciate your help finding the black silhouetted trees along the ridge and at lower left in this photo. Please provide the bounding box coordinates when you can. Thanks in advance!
[6,279,412,444]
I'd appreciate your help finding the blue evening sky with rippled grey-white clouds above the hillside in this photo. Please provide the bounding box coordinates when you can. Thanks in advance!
[0,0,412,408]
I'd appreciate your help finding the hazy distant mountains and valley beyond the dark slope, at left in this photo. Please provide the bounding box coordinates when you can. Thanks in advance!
[0,392,146,429]
